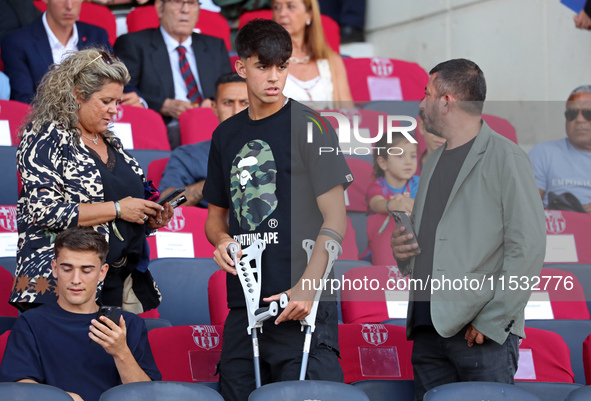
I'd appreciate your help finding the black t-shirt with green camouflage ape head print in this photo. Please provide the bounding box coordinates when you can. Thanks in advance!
[203,100,353,308]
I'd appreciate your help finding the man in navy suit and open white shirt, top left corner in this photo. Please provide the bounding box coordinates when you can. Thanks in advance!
[2,0,143,107]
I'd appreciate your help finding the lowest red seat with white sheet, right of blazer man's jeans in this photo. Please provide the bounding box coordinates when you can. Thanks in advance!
[515,327,575,383]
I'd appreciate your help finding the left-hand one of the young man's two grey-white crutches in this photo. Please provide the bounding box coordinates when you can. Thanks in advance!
[227,239,279,388]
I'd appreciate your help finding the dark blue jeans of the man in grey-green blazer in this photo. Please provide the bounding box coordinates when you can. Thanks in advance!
[412,326,519,401]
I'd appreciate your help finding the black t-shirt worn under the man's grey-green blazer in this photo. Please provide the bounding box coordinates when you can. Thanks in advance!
[413,139,474,327]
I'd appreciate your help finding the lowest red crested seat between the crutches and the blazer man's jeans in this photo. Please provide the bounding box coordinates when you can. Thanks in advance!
[339,324,413,383]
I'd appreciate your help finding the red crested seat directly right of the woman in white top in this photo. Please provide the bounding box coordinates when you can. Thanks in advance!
[343,57,429,102]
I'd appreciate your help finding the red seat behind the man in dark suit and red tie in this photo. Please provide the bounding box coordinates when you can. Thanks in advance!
[126,5,232,51]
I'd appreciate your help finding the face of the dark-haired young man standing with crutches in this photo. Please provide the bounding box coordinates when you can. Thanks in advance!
[236,55,288,108]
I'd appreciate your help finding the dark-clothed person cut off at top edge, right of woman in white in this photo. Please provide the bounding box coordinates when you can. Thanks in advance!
[318,0,366,43]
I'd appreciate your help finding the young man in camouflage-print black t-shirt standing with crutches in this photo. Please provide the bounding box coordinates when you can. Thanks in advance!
[204,20,353,401]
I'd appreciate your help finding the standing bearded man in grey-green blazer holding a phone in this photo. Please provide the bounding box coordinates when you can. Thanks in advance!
[391,59,546,400]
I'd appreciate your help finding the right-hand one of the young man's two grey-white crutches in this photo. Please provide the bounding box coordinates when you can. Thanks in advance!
[279,239,343,380]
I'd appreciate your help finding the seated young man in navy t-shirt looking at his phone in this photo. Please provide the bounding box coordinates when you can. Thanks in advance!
[0,227,162,401]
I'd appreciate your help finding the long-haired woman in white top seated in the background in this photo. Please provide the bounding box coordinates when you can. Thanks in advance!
[273,0,353,102]
